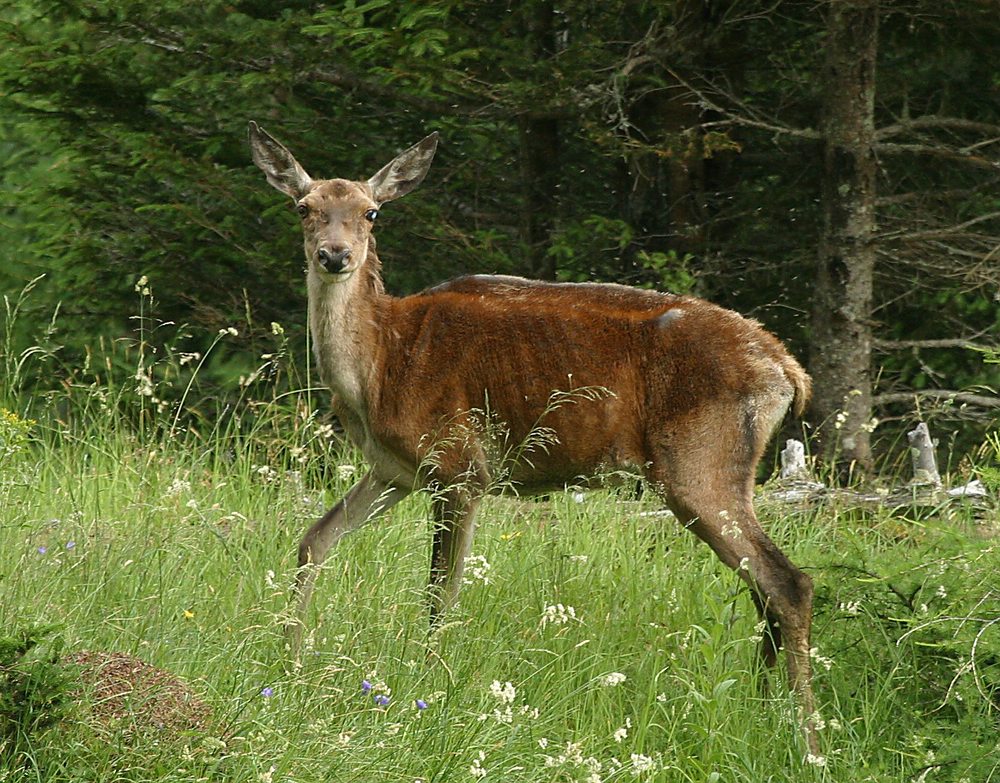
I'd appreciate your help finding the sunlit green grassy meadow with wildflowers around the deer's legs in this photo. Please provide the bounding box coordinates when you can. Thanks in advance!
[0,304,1000,783]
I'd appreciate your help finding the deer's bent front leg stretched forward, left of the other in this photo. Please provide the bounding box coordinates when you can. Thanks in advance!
[285,473,409,651]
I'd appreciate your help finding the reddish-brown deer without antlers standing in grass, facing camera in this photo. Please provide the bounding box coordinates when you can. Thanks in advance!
[249,122,817,751]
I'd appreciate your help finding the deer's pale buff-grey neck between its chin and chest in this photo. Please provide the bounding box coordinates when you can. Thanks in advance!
[307,259,389,417]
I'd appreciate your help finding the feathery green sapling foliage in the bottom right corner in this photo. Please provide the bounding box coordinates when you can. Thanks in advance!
[817,518,1000,781]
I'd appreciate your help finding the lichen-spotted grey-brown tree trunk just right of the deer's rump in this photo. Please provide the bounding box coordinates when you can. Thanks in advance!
[810,0,878,478]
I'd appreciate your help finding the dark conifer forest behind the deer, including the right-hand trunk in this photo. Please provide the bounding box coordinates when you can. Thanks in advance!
[0,0,1000,468]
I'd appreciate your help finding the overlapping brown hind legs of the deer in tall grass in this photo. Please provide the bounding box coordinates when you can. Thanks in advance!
[649,460,817,751]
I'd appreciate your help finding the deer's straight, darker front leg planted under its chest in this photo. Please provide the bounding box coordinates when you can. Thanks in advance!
[429,489,479,627]
